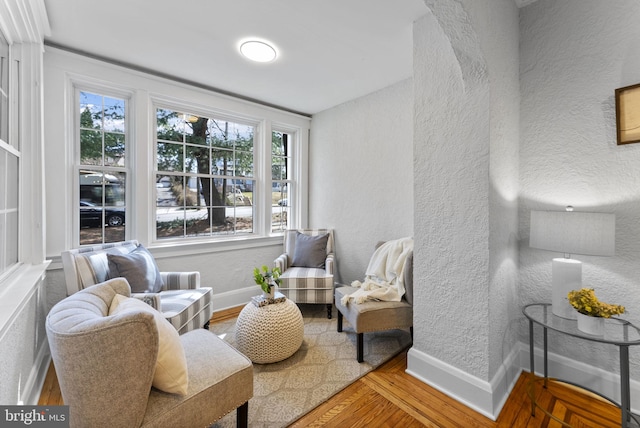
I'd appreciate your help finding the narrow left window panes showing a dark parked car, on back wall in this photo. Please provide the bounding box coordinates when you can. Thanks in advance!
[77,91,127,245]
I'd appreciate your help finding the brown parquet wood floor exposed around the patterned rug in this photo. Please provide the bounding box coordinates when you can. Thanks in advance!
[38,308,620,428]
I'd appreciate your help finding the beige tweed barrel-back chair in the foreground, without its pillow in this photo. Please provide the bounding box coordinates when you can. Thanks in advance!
[46,278,253,428]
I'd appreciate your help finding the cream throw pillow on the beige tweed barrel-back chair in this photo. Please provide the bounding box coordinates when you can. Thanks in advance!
[109,294,189,395]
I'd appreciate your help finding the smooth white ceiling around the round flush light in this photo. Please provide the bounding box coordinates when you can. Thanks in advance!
[45,0,427,114]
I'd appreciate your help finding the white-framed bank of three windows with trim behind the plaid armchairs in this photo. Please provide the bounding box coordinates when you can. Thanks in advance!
[61,53,311,249]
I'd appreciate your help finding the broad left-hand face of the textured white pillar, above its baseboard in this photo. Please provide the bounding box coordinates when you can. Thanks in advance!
[413,2,489,379]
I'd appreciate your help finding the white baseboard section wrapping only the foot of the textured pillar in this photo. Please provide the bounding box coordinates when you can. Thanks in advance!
[407,346,522,421]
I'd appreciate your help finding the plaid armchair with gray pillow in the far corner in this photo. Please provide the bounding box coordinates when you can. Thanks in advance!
[274,229,336,318]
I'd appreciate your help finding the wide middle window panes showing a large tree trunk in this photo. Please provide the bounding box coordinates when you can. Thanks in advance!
[155,108,255,240]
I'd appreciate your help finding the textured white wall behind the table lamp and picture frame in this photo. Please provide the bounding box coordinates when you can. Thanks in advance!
[519,0,640,380]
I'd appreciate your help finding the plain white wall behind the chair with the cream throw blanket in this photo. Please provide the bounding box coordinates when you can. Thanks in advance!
[309,79,413,282]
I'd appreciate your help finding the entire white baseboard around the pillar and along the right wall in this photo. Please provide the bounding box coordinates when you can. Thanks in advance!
[407,342,640,421]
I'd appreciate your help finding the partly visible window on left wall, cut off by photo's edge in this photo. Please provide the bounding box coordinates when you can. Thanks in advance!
[0,30,21,277]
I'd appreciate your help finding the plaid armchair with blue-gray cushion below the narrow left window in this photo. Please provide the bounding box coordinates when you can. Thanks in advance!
[61,240,213,334]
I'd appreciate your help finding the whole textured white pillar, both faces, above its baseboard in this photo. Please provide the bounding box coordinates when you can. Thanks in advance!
[414,1,519,388]
